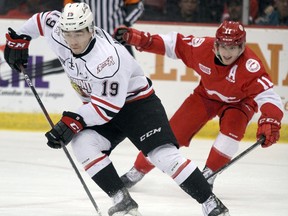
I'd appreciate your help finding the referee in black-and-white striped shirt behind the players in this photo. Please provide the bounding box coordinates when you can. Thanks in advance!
[74,0,144,55]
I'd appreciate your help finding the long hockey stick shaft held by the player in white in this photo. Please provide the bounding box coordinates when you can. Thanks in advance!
[20,65,102,216]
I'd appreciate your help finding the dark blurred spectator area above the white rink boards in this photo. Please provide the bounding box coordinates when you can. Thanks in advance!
[0,0,288,26]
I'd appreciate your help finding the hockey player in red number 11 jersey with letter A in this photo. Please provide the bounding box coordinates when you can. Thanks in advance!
[114,21,283,188]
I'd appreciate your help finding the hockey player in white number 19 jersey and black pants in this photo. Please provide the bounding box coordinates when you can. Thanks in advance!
[4,3,229,216]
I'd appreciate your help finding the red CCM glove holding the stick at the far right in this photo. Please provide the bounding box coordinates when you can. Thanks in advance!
[257,117,281,148]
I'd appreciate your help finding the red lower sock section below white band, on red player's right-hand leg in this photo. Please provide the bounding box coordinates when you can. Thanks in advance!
[206,147,231,172]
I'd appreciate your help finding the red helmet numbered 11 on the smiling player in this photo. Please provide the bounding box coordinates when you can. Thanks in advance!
[216,21,246,46]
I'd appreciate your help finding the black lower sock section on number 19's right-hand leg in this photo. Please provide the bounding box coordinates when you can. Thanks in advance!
[180,168,212,203]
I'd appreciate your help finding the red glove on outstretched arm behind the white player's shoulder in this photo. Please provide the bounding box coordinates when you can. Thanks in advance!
[113,27,152,50]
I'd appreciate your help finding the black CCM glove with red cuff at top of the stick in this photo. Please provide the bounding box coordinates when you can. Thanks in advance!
[4,28,31,72]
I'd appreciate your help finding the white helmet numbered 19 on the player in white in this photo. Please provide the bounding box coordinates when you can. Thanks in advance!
[60,3,94,32]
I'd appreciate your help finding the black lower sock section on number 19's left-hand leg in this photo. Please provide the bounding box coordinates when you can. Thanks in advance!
[92,163,124,197]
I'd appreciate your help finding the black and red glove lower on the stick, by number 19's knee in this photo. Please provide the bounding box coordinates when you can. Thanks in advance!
[45,112,86,149]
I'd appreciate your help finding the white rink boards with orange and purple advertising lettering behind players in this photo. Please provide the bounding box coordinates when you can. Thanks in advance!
[0,19,288,124]
